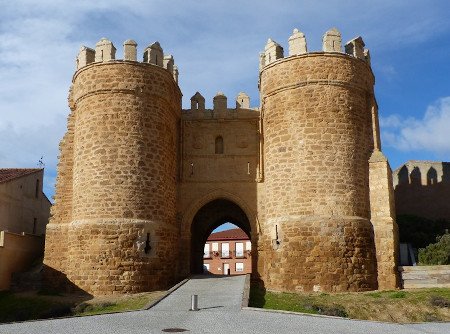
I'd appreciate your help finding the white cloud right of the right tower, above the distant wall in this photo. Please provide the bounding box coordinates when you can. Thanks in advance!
[380,97,450,159]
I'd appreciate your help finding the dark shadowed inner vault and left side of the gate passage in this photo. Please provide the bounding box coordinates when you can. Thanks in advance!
[191,199,251,274]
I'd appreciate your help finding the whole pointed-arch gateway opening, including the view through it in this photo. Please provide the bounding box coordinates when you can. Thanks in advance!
[191,199,252,275]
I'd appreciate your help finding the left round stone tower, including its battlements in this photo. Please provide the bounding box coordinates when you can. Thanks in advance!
[44,39,181,294]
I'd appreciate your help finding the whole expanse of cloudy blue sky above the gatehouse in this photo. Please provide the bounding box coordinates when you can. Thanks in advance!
[0,0,450,207]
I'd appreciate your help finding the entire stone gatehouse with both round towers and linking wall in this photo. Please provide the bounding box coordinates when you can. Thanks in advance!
[45,28,398,295]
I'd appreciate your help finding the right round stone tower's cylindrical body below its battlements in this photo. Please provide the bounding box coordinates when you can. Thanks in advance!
[259,53,377,291]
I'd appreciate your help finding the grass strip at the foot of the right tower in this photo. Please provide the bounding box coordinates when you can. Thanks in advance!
[249,285,450,323]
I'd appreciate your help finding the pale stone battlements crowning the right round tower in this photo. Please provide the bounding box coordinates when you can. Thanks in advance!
[259,28,370,71]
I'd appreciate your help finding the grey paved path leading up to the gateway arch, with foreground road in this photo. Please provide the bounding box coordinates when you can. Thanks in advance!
[0,276,450,334]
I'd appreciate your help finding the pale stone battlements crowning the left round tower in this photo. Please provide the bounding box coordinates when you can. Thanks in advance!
[76,38,179,83]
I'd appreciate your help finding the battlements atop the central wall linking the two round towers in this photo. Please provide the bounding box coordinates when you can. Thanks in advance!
[182,92,259,119]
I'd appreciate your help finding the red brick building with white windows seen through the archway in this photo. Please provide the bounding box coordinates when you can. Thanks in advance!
[203,228,252,275]
